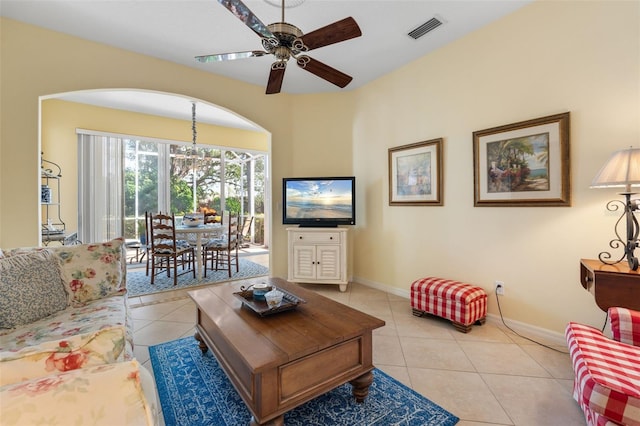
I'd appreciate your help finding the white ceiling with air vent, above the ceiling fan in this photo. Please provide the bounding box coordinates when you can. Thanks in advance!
[0,0,533,125]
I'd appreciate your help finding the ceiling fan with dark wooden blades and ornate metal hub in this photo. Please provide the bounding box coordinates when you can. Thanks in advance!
[196,0,362,95]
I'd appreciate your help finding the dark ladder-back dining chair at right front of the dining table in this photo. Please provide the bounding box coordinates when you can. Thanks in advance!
[202,212,240,278]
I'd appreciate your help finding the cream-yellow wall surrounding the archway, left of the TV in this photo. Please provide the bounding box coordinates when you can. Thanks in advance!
[0,18,292,276]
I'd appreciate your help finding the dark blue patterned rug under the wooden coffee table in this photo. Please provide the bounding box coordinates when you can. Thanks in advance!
[149,337,459,426]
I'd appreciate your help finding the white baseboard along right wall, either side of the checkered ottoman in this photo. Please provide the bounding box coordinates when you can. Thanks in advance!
[353,277,567,346]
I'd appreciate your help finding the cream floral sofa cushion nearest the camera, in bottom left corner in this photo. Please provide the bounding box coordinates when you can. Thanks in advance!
[0,360,154,426]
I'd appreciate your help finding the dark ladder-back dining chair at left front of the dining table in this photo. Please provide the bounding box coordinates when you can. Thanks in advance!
[150,213,196,285]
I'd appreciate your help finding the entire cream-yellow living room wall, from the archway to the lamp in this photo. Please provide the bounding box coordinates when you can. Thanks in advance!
[0,0,640,337]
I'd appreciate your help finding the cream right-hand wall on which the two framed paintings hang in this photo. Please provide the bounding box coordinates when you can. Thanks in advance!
[353,1,640,333]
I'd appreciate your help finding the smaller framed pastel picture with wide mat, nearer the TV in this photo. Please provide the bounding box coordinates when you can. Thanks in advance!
[389,138,443,206]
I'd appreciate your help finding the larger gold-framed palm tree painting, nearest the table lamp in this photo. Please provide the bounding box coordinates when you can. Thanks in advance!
[473,112,571,207]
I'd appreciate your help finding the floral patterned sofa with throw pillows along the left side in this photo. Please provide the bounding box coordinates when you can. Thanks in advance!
[0,238,157,425]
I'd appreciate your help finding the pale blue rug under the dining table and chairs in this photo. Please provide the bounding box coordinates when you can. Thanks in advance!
[127,257,269,297]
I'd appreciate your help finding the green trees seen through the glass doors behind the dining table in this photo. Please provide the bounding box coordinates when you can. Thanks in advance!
[124,140,265,238]
